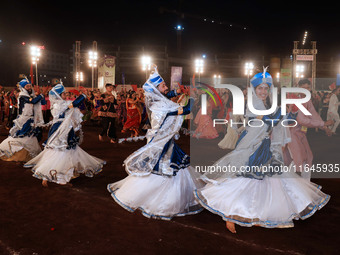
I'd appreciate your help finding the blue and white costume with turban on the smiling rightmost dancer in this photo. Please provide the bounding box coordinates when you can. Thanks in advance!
[195,72,330,228]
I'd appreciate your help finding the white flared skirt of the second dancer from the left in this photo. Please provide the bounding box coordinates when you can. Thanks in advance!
[24,145,106,184]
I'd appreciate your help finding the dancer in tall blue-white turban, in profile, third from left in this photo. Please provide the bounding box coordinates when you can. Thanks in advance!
[108,67,202,220]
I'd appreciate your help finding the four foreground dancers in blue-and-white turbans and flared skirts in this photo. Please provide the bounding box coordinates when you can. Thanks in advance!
[0,66,331,233]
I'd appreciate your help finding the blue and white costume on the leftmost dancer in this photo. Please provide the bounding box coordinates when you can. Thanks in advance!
[0,79,44,161]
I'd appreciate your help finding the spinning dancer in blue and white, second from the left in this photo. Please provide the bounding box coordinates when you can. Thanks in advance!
[24,84,105,187]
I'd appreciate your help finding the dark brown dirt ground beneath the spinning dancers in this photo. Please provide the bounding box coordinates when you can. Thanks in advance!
[0,123,340,255]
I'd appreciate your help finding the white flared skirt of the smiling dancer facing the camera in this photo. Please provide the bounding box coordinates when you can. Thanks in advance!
[195,173,330,228]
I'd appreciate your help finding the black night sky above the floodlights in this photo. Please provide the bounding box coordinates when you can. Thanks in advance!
[0,0,340,57]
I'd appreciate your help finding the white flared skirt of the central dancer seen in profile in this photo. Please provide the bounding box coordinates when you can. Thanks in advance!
[107,167,203,220]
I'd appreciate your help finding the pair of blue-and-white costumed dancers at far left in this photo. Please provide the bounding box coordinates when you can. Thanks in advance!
[0,79,105,186]
